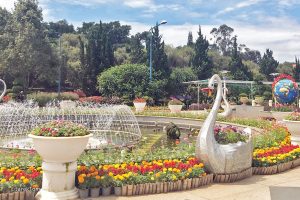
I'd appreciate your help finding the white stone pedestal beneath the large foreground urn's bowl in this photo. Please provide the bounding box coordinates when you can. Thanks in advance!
[36,161,79,200]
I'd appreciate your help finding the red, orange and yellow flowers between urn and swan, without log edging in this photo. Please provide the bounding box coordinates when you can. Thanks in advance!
[77,157,206,197]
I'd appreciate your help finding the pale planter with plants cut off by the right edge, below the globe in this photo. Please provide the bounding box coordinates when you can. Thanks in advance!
[283,112,300,144]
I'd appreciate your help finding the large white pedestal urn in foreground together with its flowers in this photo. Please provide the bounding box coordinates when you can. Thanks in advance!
[29,120,92,200]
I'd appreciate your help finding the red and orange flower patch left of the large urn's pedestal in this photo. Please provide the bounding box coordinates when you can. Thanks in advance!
[0,166,43,200]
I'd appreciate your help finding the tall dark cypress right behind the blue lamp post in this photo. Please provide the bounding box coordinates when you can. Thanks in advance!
[147,25,170,79]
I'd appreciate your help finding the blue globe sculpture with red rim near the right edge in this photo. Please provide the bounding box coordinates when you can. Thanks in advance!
[273,77,298,104]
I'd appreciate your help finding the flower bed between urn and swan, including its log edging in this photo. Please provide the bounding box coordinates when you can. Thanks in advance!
[77,157,213,196]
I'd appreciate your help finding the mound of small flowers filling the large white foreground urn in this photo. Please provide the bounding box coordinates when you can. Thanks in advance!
[31,121,89,137]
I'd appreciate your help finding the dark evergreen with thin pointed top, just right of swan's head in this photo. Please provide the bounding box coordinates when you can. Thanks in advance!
[229,36,253,80]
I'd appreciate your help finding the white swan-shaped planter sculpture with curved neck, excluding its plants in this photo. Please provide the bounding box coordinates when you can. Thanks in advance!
[196,74,252,174]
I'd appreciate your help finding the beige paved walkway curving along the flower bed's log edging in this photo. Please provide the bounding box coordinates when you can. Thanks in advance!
[93,167,300,200]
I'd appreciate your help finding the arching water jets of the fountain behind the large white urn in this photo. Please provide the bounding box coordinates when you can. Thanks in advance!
[0,102,141,150]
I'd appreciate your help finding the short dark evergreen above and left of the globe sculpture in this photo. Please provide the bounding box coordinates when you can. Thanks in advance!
[259,49,279,81]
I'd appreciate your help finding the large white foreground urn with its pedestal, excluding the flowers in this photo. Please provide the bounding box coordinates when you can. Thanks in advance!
[29,134,92,200]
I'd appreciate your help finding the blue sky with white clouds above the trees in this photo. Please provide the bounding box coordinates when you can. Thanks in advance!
[0,0,300,62]
